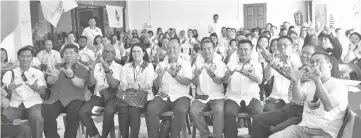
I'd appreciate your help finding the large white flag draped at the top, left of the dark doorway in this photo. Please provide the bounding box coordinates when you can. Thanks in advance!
[40,0,78,27]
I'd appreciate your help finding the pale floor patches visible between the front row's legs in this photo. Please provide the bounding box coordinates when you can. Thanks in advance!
[57,115,248,138]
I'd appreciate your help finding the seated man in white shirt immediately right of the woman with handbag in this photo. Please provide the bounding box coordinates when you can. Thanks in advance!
[146,38,192,138]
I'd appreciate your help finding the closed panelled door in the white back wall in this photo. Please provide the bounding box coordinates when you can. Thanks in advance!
[243,3,267,29]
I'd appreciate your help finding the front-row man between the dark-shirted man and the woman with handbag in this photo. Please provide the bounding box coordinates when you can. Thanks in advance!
[79,44,122,138]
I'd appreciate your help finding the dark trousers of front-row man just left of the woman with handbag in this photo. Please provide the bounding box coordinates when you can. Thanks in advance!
[79,95,117,137]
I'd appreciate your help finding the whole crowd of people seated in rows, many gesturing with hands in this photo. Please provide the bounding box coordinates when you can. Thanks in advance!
[1,15,361,138]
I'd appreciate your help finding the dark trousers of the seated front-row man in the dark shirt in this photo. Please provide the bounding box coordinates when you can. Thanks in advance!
[41,99,84,138]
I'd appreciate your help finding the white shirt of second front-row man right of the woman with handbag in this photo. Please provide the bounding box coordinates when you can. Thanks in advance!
[193,56,227,103]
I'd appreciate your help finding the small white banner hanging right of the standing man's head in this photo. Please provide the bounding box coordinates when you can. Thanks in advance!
[105,5,123,28]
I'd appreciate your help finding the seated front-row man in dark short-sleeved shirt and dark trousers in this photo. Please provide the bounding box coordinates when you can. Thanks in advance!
[41,44,89,138]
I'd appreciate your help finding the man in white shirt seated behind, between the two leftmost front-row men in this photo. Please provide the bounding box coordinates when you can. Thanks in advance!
[36,40,62,71]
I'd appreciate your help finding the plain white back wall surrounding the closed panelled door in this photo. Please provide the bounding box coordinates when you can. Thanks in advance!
[127,0,305,36]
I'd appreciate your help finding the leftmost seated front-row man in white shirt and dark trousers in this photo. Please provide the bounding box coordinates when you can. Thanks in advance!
[2,47,46,138]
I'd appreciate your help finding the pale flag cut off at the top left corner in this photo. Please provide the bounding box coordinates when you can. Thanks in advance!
[1,1,19,42]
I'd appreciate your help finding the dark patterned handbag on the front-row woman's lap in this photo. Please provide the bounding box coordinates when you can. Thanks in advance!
[117,89,148,108]
